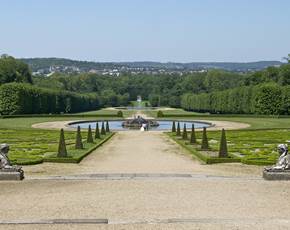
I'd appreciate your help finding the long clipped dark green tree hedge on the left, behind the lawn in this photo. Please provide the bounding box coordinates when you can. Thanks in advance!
[0,83,100,115]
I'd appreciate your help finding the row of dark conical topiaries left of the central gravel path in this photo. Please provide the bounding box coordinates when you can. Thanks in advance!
[57,121,110,157]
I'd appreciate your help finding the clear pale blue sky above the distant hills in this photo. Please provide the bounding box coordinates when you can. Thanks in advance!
[0,0,290,62]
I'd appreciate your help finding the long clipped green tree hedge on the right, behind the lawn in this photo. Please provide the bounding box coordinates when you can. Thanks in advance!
[181,83,290,116]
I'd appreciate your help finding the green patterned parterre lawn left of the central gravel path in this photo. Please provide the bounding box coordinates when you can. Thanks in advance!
[0,129,112,165]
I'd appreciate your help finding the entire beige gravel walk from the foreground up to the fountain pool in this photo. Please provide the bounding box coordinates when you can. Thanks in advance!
[0,131,290,229]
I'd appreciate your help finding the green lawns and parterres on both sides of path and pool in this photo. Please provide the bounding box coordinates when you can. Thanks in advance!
[0,105,290,165]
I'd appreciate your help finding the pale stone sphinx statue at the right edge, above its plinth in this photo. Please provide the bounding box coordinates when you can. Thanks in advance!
[265,144,290,172]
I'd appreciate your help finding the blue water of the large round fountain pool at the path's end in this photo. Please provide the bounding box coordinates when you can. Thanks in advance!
[69,120,212,131]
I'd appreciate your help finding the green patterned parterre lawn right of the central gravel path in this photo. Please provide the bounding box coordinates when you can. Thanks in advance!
[168,129,290,165]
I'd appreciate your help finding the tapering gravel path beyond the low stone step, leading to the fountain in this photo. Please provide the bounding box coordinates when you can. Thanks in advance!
[24,131,259,179]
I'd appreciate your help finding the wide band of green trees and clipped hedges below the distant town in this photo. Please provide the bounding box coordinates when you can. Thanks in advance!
[0,56,290,114]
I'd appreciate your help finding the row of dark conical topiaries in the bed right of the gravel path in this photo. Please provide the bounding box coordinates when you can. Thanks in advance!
[171,121,240,164]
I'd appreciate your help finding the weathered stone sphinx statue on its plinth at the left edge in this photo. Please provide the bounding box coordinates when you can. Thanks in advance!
[0,144,24,180]
